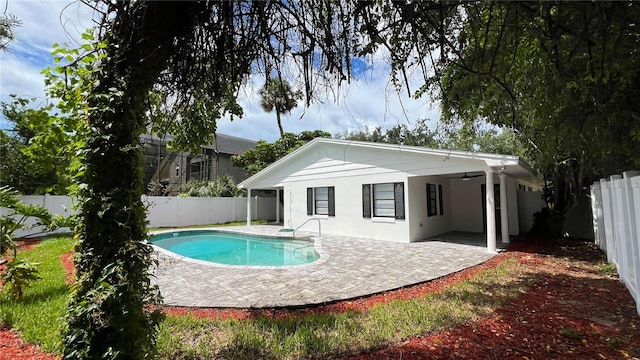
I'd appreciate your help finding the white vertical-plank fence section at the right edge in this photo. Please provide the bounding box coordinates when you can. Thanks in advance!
[591,171,640,314]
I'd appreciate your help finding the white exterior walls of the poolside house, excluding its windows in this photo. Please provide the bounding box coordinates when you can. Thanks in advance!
[243,142,536,242]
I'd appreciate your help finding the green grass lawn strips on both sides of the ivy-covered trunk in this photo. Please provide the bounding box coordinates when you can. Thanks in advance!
[0,232,535,359]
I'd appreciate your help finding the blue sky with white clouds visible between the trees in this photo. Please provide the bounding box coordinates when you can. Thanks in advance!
[0,0,439,142]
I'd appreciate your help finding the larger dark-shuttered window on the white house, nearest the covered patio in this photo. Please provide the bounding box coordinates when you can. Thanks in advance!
[362,183,404,219]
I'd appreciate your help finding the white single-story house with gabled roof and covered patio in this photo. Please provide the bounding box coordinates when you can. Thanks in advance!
[239,138,542,252]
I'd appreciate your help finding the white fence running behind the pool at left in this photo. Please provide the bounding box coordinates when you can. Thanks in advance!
[0,195,276,237]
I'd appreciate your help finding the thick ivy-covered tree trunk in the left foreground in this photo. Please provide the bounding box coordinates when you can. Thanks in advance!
[64,1,198,359]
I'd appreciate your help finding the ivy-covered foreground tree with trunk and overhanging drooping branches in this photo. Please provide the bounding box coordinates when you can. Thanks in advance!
[58,0,368,359]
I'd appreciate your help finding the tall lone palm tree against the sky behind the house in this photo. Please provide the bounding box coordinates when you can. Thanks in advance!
[258,78,302,137]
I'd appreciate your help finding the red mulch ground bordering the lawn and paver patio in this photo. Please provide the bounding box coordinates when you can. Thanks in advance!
[0,237,640,360]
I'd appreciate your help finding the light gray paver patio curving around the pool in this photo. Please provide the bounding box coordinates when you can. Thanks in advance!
[154,225,494,308]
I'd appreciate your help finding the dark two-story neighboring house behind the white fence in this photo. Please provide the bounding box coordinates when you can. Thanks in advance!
[142,134,256,195]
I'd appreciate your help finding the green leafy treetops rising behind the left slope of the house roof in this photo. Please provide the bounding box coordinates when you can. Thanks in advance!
[231,130,331,176]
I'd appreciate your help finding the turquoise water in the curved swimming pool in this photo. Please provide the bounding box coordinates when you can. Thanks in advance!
[150,230,319,266]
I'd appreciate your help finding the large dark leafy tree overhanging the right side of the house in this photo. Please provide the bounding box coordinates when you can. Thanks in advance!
[424,2,640,235]
